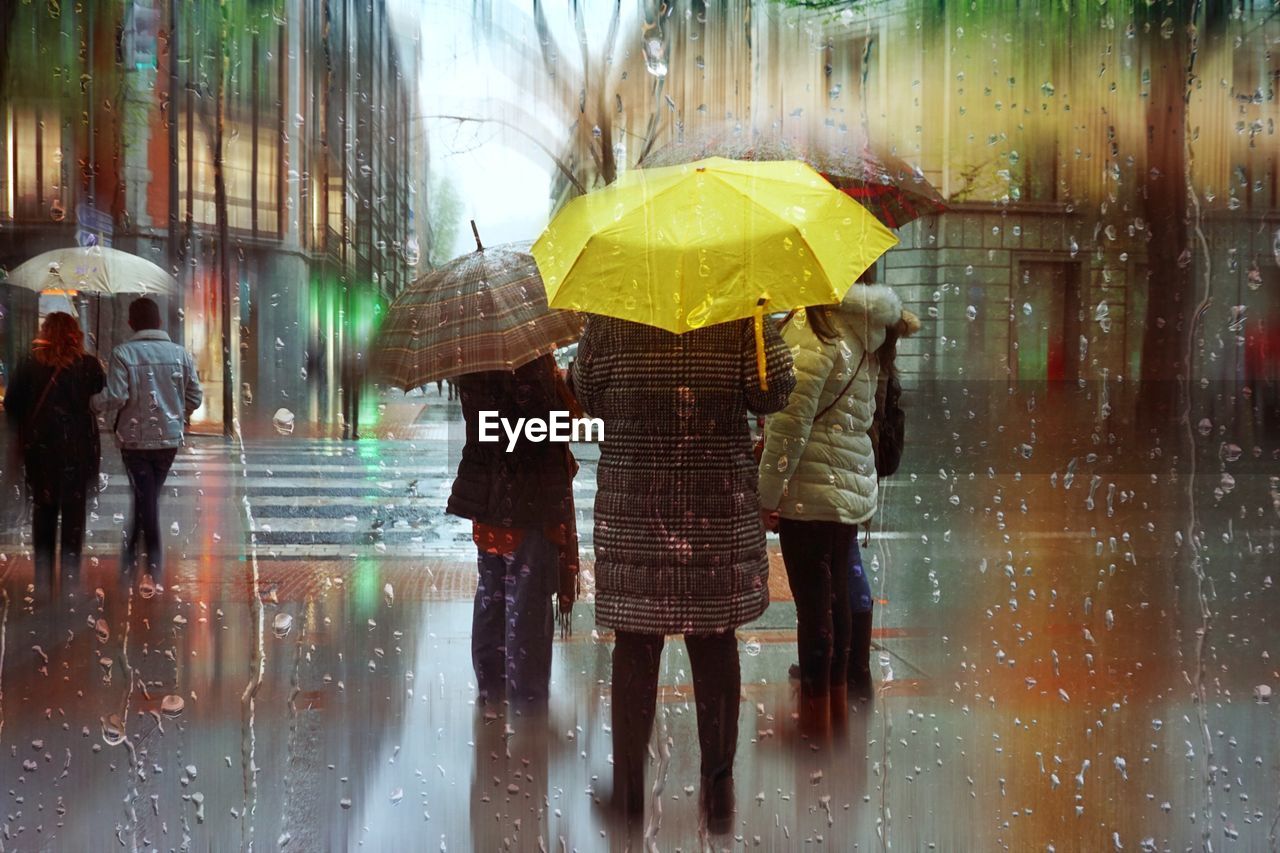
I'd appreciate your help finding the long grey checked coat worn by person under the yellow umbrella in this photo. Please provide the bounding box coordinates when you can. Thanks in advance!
[573,316,795,634]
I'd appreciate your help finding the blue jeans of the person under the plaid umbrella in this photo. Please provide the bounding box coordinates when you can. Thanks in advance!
[471,530,559,704]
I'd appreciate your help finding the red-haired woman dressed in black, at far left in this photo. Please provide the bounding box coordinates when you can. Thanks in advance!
[4,311,106,593]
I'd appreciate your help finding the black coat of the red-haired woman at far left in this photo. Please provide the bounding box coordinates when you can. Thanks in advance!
[4,355,106,503]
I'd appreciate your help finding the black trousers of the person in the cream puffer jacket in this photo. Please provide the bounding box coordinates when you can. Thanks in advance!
[778,519,858,697]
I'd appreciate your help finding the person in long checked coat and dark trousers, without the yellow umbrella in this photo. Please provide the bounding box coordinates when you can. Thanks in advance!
[571,316,795,833]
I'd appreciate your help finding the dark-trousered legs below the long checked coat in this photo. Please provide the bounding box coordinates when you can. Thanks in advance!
[612,631,742,811]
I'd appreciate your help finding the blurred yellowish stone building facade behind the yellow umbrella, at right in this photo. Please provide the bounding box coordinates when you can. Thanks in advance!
[527,0,1280,410]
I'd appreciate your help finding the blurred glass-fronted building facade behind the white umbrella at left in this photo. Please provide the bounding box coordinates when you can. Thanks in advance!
[0,0,425,434]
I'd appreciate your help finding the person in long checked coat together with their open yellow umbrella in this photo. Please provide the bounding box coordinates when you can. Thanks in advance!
[532,159,896,833]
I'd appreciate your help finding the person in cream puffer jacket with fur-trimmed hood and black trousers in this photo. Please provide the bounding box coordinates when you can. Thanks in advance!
[759,283,919,731]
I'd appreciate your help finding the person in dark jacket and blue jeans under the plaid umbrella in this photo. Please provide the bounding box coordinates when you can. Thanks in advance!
[448,356,577,706]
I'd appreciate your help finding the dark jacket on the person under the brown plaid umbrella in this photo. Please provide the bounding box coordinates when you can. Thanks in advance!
[448,356,575,529]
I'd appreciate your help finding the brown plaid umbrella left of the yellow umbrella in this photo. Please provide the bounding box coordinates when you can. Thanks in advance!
[372,237,584,391]
